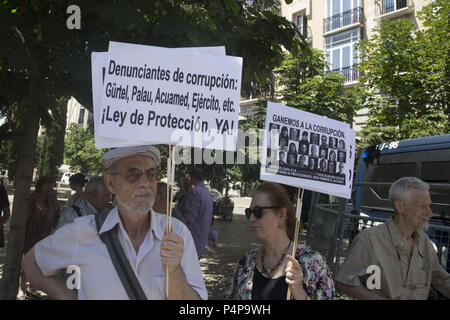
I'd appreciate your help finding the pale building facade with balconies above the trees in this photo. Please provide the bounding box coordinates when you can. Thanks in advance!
[281,0,432,131]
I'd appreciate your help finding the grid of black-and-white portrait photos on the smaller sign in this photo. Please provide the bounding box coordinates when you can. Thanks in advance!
[266,123,347,185]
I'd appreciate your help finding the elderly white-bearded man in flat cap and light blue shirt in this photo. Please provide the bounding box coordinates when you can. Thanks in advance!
[23,146,207,299]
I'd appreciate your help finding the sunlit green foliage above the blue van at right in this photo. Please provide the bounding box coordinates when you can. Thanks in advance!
[360,0,450,141]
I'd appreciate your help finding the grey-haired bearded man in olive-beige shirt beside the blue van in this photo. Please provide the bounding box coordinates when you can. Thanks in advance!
[335,177,450,300]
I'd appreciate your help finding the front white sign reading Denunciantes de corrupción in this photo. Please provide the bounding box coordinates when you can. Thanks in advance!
[96,43,242,151]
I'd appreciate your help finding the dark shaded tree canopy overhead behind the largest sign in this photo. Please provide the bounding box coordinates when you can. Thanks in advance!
[0,0,305,190]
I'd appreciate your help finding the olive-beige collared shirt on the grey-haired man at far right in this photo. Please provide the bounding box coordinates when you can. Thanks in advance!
[335,218,450,300]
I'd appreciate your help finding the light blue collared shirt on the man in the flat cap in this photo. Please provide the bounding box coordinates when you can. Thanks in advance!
[35,207,207,300]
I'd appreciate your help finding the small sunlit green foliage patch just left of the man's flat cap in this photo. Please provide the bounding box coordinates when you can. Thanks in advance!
[64,123,106,174]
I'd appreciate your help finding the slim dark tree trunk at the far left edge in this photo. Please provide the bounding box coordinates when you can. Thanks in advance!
[0,72,40,300]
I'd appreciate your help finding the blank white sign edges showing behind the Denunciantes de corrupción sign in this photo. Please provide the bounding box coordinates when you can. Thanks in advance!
[91,41,225,149]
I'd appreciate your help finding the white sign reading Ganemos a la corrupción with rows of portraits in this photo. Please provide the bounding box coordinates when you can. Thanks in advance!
[261,102,355,199]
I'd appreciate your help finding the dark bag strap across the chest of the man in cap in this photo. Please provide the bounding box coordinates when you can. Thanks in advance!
[95,211,147,300]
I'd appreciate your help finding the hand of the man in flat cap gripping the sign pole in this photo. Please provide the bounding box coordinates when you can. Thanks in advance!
[161,232,184,273]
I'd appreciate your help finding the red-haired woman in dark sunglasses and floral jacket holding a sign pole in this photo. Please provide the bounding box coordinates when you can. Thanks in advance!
[225,182,335,300]
